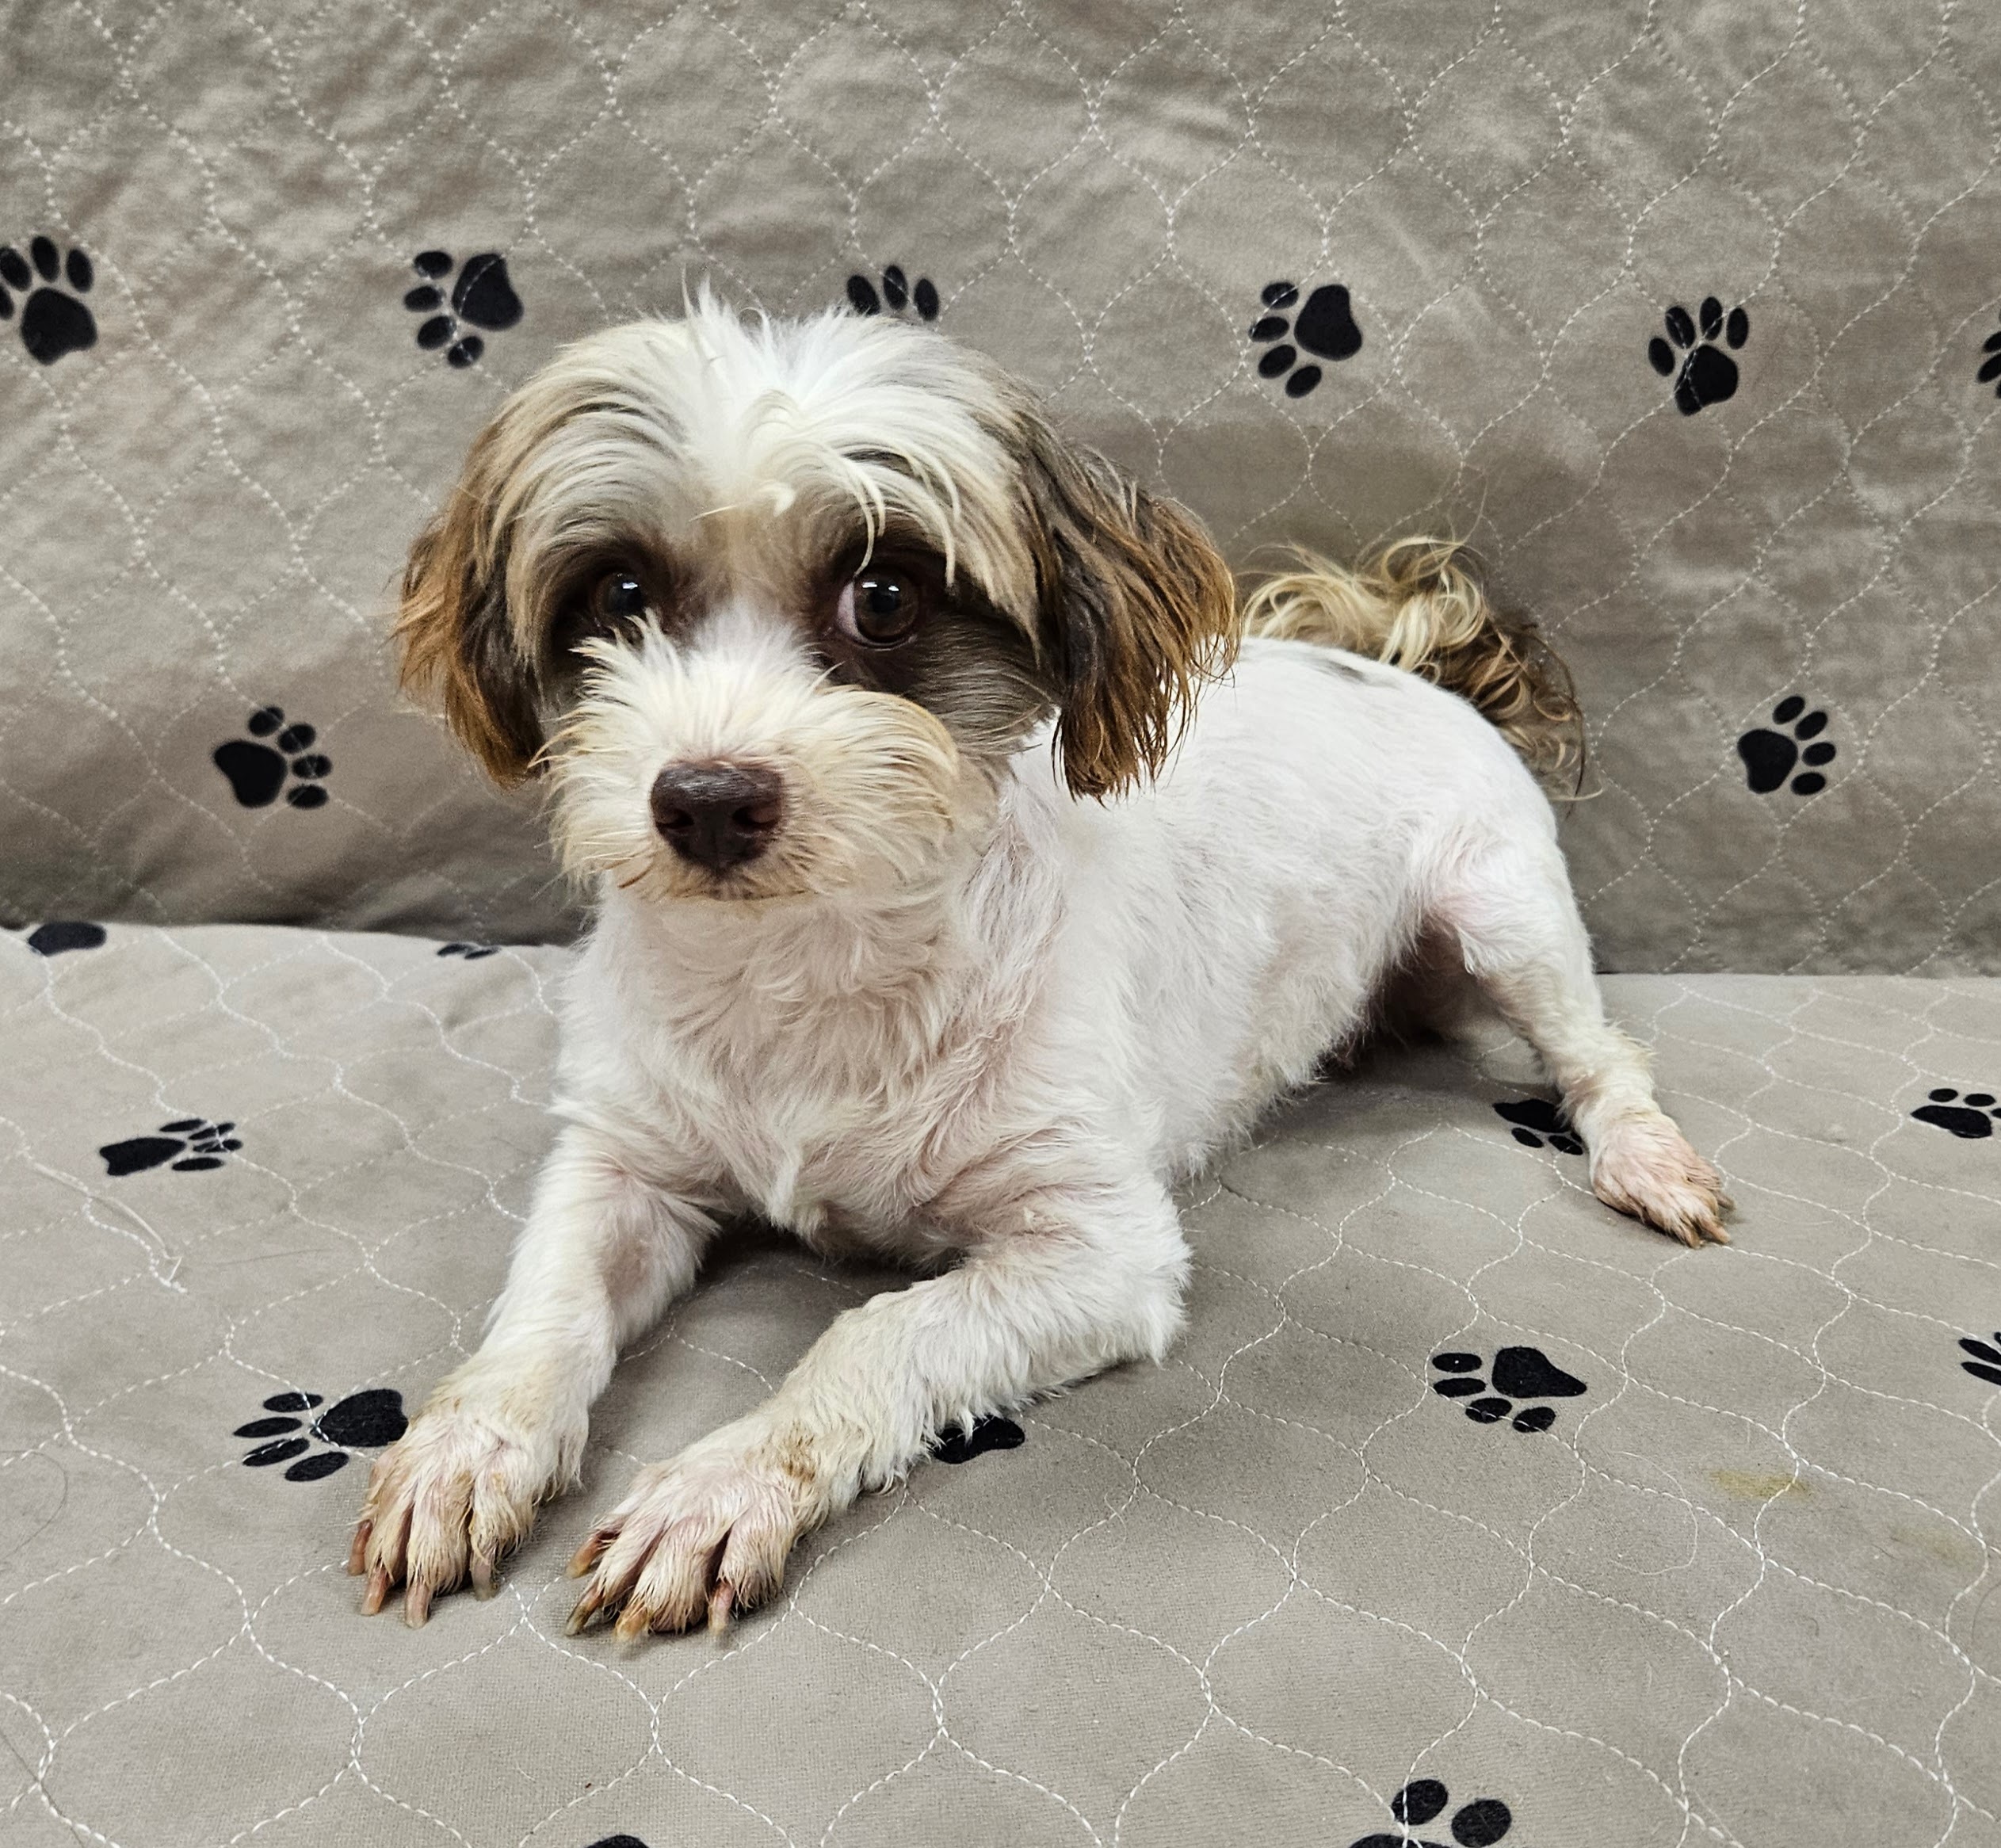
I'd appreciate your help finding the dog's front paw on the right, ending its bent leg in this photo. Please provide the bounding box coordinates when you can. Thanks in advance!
[571,1418,831,1638]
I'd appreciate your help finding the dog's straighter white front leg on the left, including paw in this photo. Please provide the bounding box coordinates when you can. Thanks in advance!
[348,1126,714,1624]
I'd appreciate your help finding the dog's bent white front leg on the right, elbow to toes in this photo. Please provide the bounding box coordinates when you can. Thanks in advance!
[571,1178,1189,1636]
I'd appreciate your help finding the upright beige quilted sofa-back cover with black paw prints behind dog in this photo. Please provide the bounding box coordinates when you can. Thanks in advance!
[0,0,2001,972]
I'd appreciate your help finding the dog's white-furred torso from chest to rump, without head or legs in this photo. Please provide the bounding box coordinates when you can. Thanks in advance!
[564,644,1548,1254]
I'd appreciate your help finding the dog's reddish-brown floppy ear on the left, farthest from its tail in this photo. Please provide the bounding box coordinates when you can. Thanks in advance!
[396,412,542,784]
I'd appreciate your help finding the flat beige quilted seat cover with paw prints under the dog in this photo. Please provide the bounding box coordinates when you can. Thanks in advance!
[0,926,2001,1848]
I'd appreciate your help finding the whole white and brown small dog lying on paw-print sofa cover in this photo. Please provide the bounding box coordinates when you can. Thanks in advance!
[350,294,1729,1638]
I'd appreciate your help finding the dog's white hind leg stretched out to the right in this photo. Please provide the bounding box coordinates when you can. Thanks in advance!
[1430,834,1729,1246]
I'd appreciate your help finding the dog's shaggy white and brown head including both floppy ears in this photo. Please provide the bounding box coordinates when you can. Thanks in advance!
[398,300,1235,900]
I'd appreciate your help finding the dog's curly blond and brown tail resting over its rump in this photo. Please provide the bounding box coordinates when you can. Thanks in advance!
[1243,538,1585,788]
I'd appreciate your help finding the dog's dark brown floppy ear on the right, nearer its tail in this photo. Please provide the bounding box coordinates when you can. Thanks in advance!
[1018,414,1236,796]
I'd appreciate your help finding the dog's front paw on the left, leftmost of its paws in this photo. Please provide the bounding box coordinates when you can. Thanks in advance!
[348,1402,582,1626]
